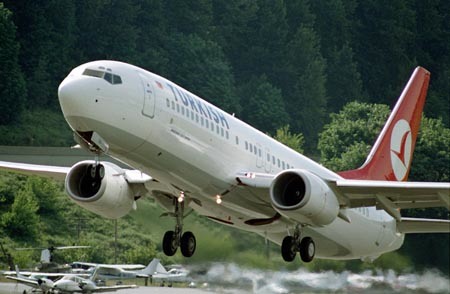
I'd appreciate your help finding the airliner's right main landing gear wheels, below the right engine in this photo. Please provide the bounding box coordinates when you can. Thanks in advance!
[281,226,316,262]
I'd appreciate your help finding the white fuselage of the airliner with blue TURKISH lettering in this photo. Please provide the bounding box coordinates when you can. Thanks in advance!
[59,61,404,259]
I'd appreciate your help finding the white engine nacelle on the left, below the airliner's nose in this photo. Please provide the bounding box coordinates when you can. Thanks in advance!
[65,160,135,219]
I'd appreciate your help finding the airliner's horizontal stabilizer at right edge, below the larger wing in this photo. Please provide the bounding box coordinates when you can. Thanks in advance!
[397,217,450,234]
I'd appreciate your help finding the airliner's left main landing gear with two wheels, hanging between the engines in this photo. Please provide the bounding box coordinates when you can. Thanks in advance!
[163,197,196,257]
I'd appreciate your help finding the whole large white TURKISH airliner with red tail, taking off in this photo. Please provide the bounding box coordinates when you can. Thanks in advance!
[0,60,450,262]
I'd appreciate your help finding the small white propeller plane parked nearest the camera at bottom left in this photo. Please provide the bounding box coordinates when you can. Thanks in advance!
[52,268,137,293]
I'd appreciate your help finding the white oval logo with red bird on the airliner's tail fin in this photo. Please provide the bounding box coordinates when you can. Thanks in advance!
[391,119,412,181]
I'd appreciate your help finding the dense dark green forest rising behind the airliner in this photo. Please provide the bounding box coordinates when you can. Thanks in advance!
[0,0,450,272]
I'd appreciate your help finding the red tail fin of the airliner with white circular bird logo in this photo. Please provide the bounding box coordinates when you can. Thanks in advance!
[339,67,430,181]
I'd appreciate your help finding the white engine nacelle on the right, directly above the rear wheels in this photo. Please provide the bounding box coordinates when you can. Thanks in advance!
[270,170,339,226]
